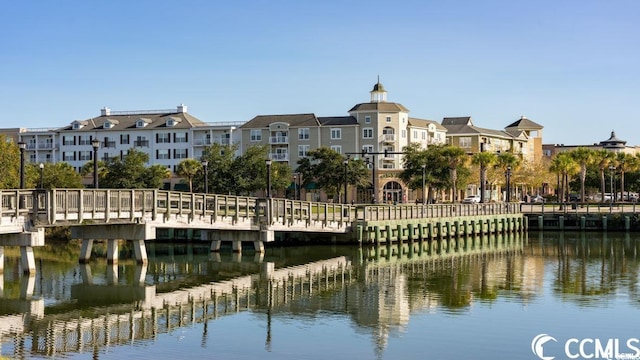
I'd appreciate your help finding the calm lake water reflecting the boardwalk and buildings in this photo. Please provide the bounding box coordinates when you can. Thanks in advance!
[0,232,640,359]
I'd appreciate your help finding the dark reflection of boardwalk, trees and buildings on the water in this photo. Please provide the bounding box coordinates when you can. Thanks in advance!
[0,232,640,359]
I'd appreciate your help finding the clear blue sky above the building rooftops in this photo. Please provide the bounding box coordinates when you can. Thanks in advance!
[0,0,640,145]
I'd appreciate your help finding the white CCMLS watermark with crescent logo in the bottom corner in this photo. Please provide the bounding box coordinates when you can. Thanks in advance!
[531,334,640,360]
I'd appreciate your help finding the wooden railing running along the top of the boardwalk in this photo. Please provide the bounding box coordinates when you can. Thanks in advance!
[0,189,521,225]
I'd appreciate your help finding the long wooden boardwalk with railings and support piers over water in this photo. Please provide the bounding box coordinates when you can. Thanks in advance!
[0,189,526,272]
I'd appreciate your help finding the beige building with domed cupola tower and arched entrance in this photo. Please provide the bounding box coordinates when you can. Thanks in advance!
[239,82,447,202]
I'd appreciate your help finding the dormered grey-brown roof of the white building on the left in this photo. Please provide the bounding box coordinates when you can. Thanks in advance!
[57,111,207,132]
